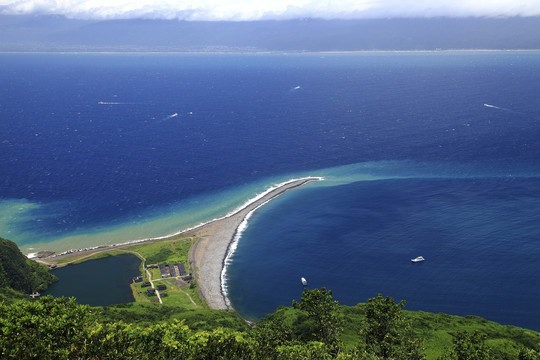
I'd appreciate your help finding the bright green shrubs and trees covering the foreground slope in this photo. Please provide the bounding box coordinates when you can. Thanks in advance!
[0,289,540,360]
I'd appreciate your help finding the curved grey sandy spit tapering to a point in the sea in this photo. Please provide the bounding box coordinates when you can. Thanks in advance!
[189,178,321,309]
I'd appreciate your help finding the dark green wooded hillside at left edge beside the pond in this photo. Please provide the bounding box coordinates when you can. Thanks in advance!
[0,238,56,294]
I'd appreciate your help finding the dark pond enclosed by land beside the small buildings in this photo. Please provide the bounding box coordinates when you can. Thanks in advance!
[45,254,141,306]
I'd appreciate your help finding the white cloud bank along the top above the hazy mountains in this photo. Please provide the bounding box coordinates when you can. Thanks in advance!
[0,0,540,21]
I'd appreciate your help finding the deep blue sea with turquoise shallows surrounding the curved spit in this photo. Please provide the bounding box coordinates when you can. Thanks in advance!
[0,51,540,330]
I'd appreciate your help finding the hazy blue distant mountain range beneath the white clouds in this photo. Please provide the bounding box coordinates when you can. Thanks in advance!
[0,15,540,52]
